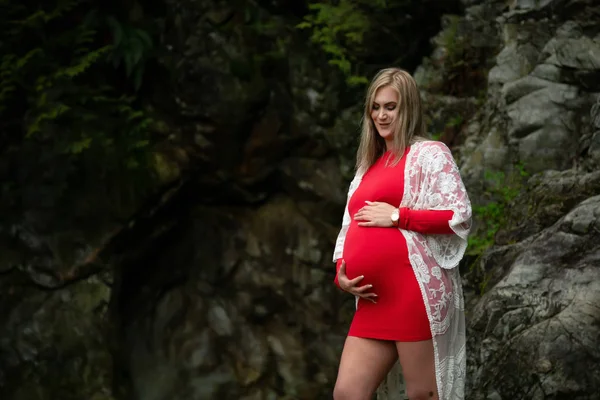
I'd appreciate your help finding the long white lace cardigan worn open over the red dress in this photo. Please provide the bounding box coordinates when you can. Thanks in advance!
[333,141,471,400]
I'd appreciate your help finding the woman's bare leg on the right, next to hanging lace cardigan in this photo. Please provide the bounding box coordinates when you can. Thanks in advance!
[396,340,439,400]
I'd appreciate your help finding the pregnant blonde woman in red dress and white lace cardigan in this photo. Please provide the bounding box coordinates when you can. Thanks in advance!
[333,68,471,400]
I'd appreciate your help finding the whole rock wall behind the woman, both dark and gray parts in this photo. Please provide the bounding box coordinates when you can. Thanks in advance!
[0,0,600,400]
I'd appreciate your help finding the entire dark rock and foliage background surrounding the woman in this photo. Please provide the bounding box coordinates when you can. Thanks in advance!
[0,0,600,400]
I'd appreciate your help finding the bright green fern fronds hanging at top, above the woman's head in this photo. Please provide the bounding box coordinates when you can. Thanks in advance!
[297,0,387,86]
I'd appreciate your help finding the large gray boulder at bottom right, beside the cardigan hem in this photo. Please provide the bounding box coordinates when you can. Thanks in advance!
[469,196,600,400]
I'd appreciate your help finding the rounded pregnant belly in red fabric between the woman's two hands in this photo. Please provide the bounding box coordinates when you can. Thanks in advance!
[343,221,409,285]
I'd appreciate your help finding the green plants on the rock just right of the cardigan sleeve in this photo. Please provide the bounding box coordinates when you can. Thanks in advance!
[467,164,529,256]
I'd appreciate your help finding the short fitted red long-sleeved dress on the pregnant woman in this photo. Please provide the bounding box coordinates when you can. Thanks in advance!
[335,149,453,342]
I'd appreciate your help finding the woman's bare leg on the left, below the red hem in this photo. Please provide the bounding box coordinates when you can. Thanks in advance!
[333,336,398,400]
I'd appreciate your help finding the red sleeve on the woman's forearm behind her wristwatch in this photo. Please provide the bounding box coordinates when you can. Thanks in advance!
[398,207,454,235]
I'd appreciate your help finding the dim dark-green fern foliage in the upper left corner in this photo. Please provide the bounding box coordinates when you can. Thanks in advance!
[0,0,153,188]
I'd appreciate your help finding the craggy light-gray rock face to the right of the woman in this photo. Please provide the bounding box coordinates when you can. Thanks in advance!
[423,1,600,399]
